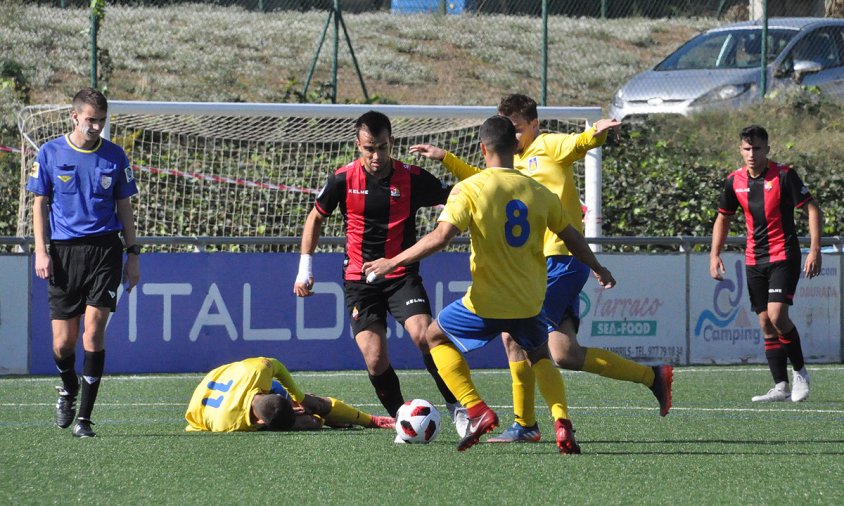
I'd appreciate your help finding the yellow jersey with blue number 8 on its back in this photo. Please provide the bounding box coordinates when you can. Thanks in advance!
[438,168,571,319]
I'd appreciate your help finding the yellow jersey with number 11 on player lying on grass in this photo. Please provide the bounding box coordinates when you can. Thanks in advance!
[185,357,305,432]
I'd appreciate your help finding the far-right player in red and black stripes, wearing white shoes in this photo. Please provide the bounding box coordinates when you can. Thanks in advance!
[709,125,823,402]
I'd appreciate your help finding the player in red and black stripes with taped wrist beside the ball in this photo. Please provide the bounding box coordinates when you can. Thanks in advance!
[293,111,468,436]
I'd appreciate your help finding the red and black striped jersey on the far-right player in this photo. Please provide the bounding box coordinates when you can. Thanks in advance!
[718,160,812,265]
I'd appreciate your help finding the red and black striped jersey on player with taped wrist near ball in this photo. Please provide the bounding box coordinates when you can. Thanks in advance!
[314,159,451,281]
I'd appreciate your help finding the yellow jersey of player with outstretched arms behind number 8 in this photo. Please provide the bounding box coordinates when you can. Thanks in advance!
[442,126,607,257]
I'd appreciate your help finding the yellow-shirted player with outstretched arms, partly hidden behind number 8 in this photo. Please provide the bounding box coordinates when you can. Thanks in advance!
[410,94,673,443]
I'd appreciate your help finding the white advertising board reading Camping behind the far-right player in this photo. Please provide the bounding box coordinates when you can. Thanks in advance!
[689,253,841,364]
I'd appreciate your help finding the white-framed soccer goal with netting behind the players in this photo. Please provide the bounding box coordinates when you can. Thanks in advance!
[18,101,600,251]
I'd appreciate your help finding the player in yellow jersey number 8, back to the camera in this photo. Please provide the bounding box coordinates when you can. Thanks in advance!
[364,116,615,454]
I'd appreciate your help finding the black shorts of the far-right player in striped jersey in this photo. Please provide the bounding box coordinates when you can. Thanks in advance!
[744,255,800,314]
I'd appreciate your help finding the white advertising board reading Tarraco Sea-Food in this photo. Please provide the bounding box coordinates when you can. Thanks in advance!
[577,254,686,364]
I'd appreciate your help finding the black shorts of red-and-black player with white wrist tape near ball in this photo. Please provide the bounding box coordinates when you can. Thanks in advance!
[344,274,431,335]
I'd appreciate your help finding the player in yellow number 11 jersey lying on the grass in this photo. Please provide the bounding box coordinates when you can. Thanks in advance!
[185,357,396,432]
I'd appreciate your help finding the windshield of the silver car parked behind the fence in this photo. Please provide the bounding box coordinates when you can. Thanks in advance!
[654,28,797,70]
